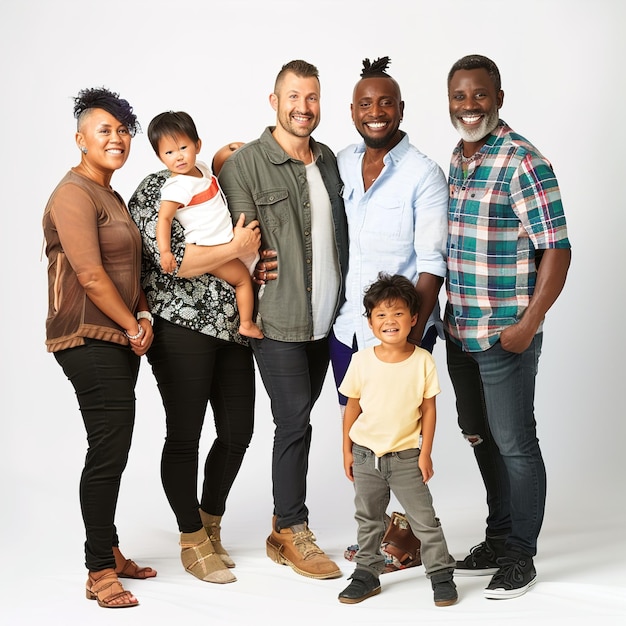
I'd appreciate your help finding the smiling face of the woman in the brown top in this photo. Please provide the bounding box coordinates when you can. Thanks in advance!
[76,109,131,174]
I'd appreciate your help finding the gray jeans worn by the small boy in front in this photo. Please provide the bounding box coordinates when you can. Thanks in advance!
[352,443,455,576]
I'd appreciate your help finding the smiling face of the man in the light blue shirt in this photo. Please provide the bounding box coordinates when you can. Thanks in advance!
[350,76,404,148]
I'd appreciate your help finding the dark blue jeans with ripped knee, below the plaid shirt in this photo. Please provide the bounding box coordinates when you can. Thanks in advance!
[446,333,546,556]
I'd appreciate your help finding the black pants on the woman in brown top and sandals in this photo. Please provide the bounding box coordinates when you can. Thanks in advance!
[54,339,139,571]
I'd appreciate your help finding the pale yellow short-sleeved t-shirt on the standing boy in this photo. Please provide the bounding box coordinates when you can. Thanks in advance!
[339,347,441,456]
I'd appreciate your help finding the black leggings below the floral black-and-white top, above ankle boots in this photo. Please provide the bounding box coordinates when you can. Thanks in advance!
[148,317,255,533]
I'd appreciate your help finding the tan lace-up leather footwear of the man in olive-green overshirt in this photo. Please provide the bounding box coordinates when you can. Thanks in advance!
[265,523,341,579]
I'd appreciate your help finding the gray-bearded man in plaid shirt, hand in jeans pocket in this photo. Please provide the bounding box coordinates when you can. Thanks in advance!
[444,55,571,599]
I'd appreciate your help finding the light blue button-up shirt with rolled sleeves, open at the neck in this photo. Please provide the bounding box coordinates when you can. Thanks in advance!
[333,134,448,349]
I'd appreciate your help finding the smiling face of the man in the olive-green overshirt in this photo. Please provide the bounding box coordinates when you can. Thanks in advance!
[270,72,321,137]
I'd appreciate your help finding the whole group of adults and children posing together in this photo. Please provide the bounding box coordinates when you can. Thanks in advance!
[43,55,570,608]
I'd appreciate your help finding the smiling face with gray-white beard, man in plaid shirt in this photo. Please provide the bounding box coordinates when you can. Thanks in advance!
[448,68,504,156]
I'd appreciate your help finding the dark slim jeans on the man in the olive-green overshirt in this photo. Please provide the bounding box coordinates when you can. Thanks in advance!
[250,337,329,528]
